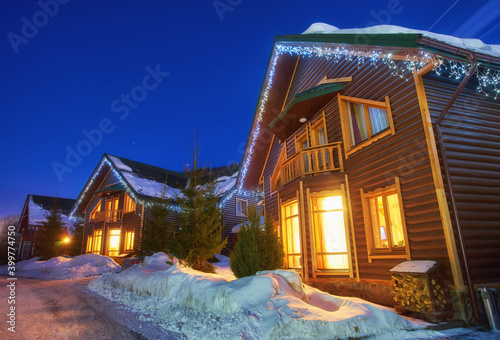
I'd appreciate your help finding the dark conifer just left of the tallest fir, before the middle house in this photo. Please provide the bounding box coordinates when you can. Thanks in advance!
[139,180,173,255]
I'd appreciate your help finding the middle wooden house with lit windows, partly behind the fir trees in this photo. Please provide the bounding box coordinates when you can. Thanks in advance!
[71,154,256,262]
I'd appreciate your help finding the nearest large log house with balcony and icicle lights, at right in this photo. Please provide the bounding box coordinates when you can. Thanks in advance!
[238,24,500,318]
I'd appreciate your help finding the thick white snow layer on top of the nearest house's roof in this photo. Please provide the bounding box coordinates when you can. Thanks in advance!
[302,23,500,57]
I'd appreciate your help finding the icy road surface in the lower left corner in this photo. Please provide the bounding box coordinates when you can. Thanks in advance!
[0,276,182,340]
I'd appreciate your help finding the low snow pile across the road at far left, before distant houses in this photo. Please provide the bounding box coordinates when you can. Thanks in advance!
[10,254,120,280]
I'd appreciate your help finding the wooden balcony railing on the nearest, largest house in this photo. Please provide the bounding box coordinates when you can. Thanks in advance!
[281,142,344,185]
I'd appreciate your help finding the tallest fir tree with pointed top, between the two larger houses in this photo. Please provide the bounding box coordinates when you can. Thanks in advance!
[172,137,227,273]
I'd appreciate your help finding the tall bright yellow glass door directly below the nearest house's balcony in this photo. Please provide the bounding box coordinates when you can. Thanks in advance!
[312,195,349,270]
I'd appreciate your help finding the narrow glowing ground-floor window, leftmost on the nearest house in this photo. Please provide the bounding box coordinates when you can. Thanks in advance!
[283,201,301,269]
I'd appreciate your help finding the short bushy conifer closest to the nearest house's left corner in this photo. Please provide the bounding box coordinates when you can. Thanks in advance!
[230,206,285,278]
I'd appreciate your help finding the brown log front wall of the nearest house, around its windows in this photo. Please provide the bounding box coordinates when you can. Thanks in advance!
[263,57,453,290]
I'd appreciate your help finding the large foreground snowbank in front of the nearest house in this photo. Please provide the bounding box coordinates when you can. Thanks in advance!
[89,254,425,339]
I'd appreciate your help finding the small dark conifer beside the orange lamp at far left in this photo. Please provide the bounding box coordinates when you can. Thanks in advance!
[35,199,65,259]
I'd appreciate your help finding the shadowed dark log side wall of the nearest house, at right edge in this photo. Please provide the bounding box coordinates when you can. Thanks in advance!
[423,72,500,283]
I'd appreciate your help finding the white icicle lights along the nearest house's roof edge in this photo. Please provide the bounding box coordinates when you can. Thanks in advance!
[238,43,500,190]
